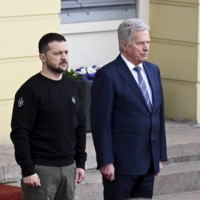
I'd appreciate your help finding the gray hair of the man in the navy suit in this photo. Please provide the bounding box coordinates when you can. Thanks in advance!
[118,18,150,52]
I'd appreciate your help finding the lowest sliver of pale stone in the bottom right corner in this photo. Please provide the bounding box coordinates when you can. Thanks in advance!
[153,190,200,200]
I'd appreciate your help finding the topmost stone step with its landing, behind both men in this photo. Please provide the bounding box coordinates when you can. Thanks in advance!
[0,121,200,183]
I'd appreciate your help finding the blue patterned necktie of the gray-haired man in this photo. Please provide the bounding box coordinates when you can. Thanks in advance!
[133,66,152,112]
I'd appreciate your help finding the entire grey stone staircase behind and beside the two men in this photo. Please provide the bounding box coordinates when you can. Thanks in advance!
[0,121,200,200]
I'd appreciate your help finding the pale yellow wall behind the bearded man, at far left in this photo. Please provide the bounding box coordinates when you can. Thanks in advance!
[0,0,60,145]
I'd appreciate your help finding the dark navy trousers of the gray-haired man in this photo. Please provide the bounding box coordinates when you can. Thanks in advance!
[103,166,155,200]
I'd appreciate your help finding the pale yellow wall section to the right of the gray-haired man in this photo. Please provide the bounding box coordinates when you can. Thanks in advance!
[149,0,200,123]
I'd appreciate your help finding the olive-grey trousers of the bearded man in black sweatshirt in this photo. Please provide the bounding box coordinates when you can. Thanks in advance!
[21,164,76,200]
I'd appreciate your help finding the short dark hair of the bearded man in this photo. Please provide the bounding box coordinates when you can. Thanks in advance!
[38,33,66,53]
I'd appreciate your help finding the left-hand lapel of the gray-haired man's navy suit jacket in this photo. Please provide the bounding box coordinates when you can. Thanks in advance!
[115,55,149,110]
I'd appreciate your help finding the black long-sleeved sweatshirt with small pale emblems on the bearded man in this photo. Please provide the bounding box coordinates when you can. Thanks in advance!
[11,73,86,177]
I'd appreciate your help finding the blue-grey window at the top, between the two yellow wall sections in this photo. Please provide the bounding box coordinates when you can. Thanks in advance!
[60,0,136,24]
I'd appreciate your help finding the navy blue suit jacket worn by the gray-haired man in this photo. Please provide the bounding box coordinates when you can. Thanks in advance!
[90,55,167,175]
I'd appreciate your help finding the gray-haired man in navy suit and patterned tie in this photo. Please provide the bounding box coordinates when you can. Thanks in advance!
[91,19,167,200]
